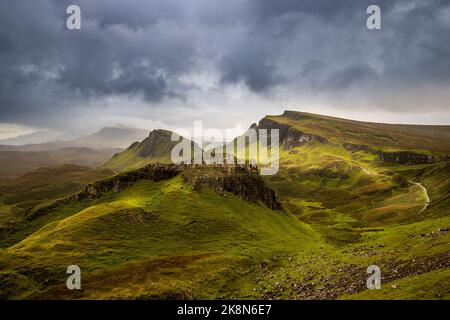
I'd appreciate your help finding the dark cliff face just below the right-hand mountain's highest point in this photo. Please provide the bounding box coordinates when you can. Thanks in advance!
[257,117,327,149]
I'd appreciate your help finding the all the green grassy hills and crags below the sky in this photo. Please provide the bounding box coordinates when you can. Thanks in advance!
[0,111,450,299]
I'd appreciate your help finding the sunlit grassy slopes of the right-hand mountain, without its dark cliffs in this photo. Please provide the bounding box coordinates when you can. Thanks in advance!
[250,113,450,298]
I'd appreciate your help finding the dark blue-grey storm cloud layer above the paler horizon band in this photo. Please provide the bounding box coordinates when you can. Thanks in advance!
[0,0,450,129]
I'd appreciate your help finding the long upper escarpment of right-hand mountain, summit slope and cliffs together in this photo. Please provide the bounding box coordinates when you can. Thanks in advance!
[246,111,446,169]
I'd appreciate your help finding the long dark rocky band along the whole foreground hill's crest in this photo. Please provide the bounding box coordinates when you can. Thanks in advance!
[26,164,281,220]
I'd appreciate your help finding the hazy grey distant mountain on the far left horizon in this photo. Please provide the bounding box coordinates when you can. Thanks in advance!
[0,127,147,151]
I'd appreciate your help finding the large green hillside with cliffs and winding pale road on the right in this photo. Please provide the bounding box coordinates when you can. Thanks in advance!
[227,111,450,298]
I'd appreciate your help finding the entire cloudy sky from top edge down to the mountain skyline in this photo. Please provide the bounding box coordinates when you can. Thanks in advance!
[0,0,450,139]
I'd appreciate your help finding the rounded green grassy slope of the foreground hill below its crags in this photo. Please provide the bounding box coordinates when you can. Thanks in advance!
[0,176,320,298]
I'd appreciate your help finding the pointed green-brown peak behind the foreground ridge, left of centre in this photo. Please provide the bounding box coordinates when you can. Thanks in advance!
[104,129,201,171]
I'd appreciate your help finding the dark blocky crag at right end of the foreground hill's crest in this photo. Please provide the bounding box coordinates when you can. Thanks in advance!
[184,165,281,210]
